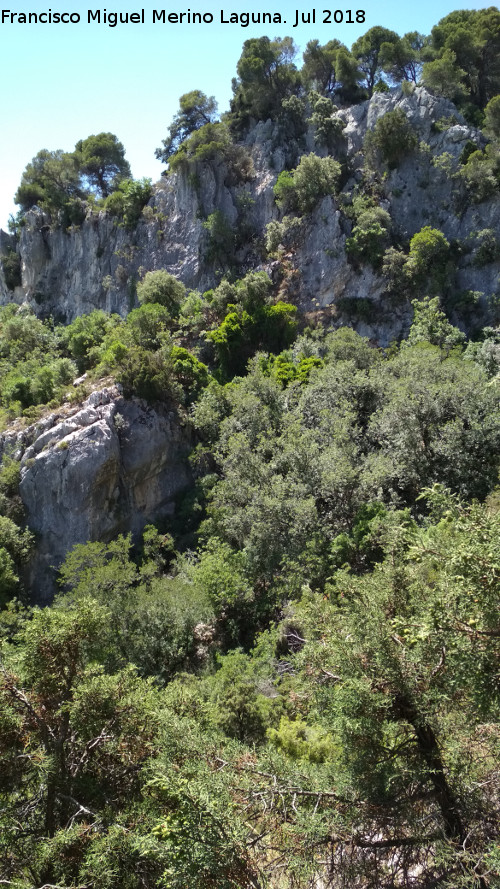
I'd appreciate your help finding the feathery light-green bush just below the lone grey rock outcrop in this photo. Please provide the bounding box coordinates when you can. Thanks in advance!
[59,528,213,683]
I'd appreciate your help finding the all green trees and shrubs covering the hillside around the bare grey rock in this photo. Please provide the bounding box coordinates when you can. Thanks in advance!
[0,7,500,889]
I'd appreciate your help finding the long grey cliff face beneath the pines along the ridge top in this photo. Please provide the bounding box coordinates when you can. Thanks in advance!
[4,87,500,344]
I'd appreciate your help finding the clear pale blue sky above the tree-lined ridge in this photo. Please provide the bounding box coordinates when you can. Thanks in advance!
[0,0,492,228]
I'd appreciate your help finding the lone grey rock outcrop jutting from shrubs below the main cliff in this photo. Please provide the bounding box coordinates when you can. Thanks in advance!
[3,387,190,603]
